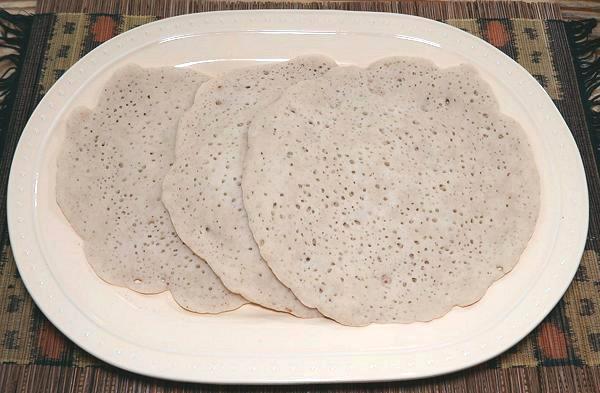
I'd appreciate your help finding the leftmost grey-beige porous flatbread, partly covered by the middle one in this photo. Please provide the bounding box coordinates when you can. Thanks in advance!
[56,65,247,313]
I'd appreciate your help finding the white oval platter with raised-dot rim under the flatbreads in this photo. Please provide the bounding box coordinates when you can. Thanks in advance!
[8,11,588,383]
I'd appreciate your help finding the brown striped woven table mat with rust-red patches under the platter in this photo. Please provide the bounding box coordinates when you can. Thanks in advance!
[0,0,600,393]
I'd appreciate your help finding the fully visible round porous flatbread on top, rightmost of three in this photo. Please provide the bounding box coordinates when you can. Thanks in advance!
[242,58,540,325]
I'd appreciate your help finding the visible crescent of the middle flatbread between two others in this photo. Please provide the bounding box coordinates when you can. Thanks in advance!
[162,56,336,317]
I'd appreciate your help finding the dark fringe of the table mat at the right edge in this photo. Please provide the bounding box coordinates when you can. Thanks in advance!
[565,19,600,168]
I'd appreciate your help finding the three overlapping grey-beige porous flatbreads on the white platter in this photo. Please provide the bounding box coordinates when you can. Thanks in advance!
[56,56,540,326]
